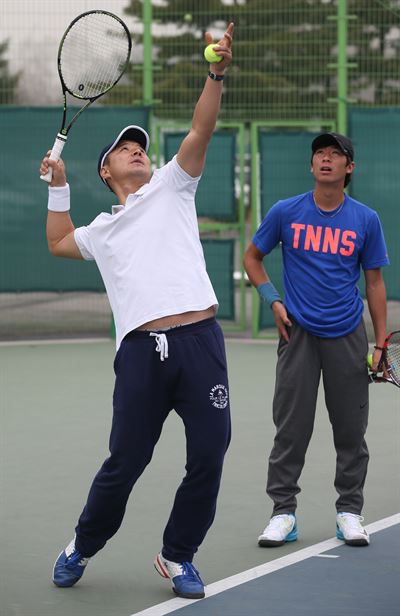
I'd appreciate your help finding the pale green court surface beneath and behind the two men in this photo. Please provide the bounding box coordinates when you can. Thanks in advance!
[0,340,400,616]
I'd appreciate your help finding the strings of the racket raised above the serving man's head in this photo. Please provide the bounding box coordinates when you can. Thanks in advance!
[59,13,130,99]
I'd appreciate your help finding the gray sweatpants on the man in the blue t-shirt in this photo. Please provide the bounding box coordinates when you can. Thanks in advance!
[267,321,369,515]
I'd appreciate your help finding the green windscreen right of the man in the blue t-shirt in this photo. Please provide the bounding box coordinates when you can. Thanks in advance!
[349,107,400,300]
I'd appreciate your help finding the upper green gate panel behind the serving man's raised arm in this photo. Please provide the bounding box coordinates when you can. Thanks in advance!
[164,131,238,222]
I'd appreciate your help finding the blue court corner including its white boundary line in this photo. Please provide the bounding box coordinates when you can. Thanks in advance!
[132,514,400,616]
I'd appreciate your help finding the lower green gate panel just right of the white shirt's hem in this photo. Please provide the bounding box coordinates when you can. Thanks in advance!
[201,239,235,320]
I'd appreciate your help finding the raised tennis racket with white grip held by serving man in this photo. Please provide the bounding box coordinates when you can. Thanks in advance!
[40,11,132,182]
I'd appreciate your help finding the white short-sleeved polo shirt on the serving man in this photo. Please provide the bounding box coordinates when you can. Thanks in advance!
[74,156,218,349]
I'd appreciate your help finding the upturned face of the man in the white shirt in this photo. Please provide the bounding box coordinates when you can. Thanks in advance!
[102,140,151,184]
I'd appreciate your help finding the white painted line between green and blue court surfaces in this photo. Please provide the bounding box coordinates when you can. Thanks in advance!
[131,513,400,616]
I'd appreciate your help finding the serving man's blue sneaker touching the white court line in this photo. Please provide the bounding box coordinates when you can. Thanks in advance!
[154,552,205,599]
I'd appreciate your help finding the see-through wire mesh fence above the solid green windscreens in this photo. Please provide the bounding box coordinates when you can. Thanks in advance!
[0,0,400,121]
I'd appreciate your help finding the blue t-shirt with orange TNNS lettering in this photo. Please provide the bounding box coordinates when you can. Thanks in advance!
[253,192,389,338]
